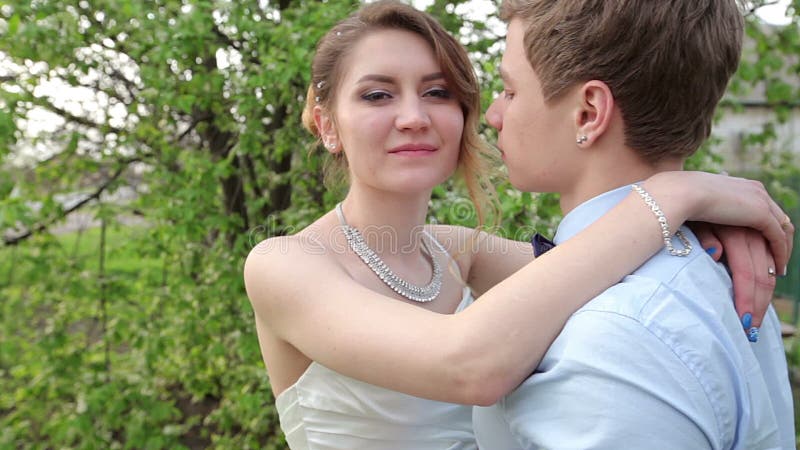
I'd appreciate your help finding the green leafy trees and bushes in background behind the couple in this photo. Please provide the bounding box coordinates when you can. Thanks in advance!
[0,0,800,449]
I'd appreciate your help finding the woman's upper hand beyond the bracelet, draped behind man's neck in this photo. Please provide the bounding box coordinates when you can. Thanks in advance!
[645,172,794,275]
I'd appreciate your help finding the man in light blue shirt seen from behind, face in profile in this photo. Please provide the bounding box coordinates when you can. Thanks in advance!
[474,0,795,450]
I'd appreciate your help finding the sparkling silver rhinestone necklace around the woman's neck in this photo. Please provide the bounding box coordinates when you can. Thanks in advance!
[336,203,442,303]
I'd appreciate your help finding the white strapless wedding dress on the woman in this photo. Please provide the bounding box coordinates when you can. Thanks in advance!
[275,287,478,450]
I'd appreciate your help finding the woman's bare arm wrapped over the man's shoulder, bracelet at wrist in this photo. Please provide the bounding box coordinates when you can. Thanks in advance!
[245,173,786,405]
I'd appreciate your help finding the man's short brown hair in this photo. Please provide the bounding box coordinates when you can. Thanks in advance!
[500,0,744,162]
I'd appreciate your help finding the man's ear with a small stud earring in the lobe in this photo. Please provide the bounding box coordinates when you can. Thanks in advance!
[575,80,614,147]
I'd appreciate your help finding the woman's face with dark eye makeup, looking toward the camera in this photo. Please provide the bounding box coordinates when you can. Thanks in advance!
[328,30,464,193]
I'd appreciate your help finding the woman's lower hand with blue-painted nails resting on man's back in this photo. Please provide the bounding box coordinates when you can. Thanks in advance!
[691,223,775,342]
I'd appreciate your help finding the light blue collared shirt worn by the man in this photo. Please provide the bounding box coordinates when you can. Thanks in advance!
[473,186,795,450]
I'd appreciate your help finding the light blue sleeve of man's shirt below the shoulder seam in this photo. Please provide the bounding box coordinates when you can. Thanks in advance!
[499,311,720,450]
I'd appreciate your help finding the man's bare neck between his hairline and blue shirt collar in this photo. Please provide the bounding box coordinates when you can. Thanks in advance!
[560,160,683,215]
